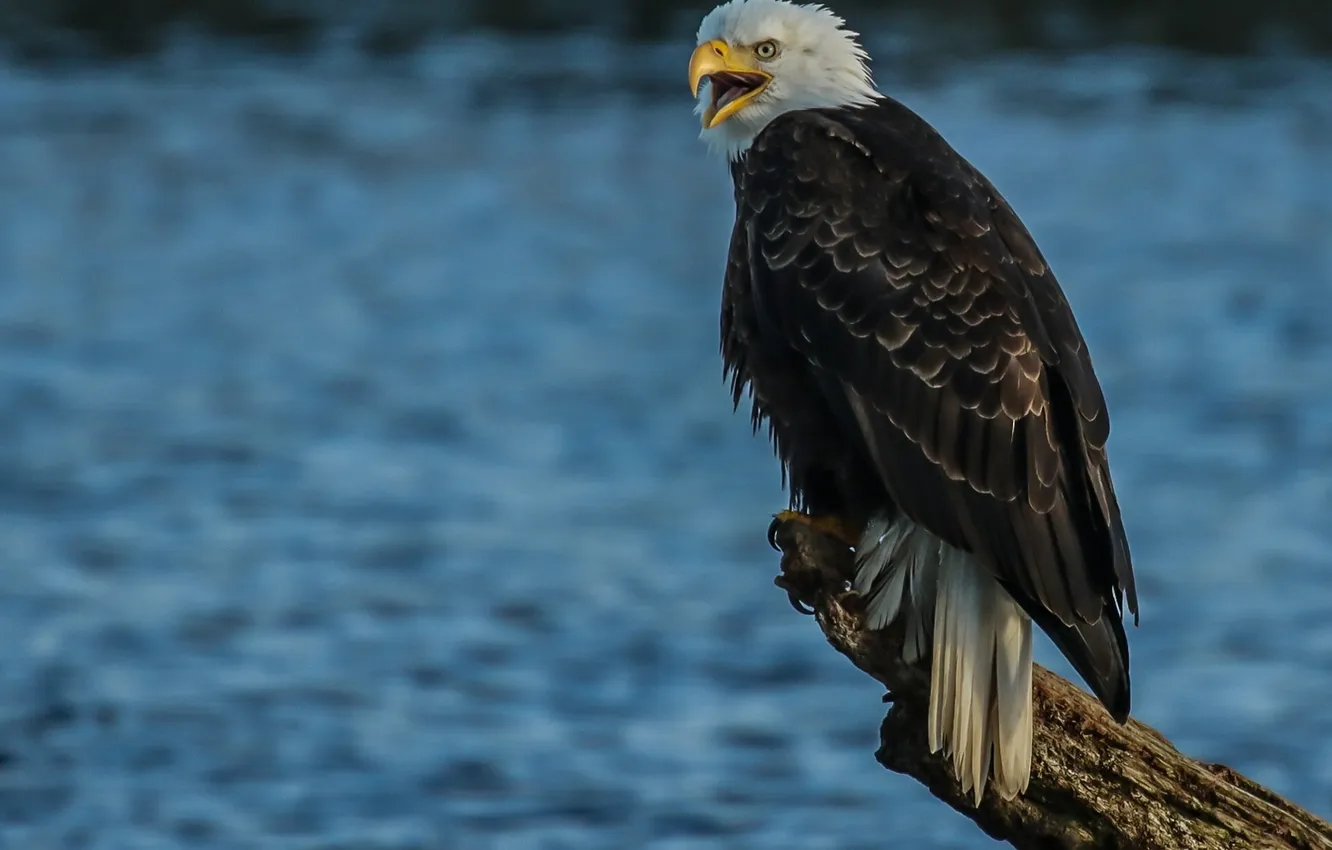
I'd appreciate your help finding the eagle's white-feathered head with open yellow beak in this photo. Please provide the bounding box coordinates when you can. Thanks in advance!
[689,0,879,159]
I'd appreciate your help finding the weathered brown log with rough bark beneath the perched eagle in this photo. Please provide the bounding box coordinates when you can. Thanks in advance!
[774,522,1332,850]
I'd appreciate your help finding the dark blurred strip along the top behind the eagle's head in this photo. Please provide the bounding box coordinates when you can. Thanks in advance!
[0,0,1332,56]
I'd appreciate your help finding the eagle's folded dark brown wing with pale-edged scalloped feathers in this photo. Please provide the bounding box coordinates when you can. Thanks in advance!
[735,100,1138,717]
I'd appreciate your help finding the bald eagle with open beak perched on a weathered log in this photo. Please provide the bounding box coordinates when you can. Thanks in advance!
[689,0,1138,805]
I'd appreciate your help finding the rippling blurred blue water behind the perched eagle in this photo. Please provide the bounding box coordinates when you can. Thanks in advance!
[0,41,1332,850]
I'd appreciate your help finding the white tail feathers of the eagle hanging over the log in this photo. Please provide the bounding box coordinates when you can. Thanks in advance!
[855,518,1031,805]
